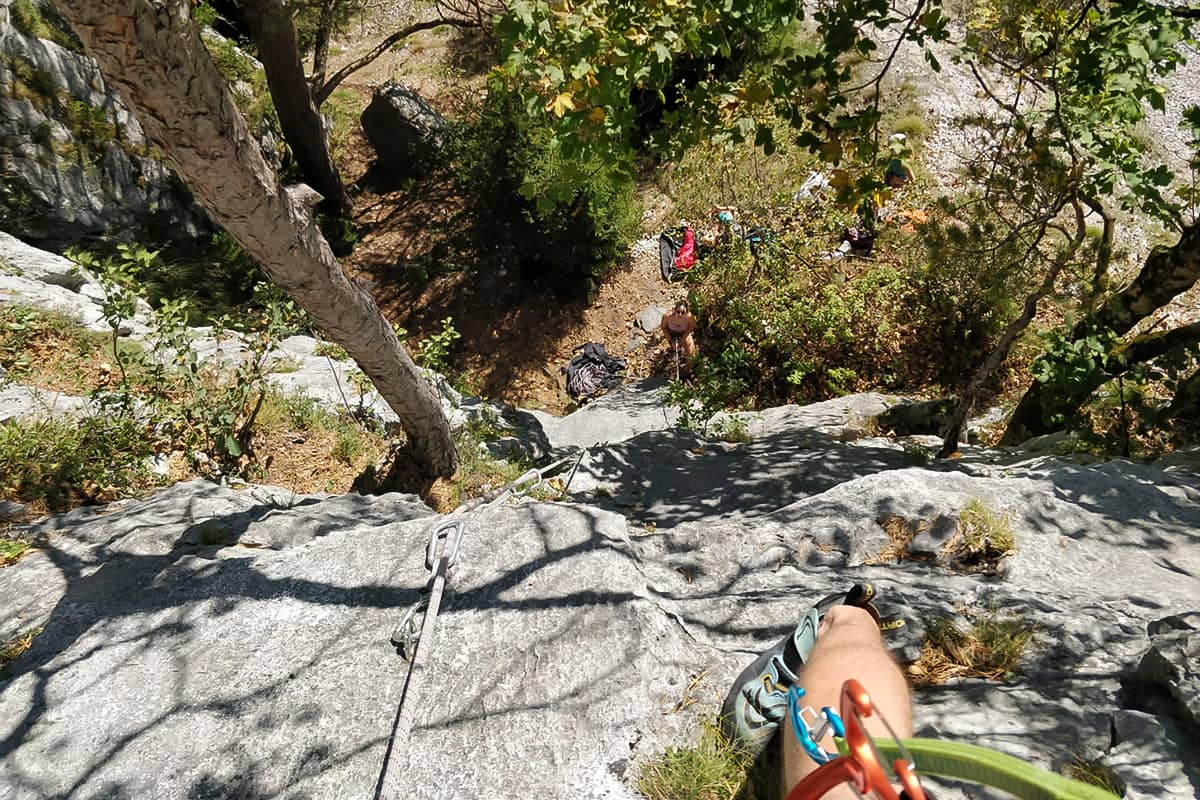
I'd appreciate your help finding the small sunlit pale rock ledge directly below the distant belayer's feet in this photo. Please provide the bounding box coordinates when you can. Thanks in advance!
[529,378,679,449]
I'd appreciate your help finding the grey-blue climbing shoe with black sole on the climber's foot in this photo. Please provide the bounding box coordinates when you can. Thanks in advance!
[721,583,904,757]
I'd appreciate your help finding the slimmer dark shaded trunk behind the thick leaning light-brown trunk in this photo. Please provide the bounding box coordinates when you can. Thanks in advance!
[241,0,353,217]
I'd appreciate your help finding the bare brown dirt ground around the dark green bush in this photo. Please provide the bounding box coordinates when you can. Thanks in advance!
[319,28,683,413]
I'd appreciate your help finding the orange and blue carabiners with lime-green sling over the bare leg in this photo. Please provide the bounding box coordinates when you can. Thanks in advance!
[787,679,1112,800]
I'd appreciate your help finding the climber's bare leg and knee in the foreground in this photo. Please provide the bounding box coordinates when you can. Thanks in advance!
[781,606,912,800]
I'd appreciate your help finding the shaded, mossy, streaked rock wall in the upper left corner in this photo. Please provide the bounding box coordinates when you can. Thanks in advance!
[0,1,210,243]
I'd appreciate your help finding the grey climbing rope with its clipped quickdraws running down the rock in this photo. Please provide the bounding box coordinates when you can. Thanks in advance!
[374,450,586,800]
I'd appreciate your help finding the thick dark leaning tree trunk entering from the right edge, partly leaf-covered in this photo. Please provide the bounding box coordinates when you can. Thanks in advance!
[1001,221,1200,445]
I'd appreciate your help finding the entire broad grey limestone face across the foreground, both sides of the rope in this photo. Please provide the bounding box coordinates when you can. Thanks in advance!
[0,385,1200,800]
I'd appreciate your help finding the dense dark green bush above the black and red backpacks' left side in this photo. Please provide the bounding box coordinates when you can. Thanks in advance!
[451,85,640,294]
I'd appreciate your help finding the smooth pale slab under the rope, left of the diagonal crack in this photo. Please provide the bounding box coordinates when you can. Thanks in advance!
[0,496,706,800]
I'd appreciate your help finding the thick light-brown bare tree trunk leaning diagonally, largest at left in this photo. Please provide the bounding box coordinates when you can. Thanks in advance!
[55,0,457,476]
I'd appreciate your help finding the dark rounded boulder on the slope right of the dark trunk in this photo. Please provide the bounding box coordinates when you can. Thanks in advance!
[361,80,446,178]
